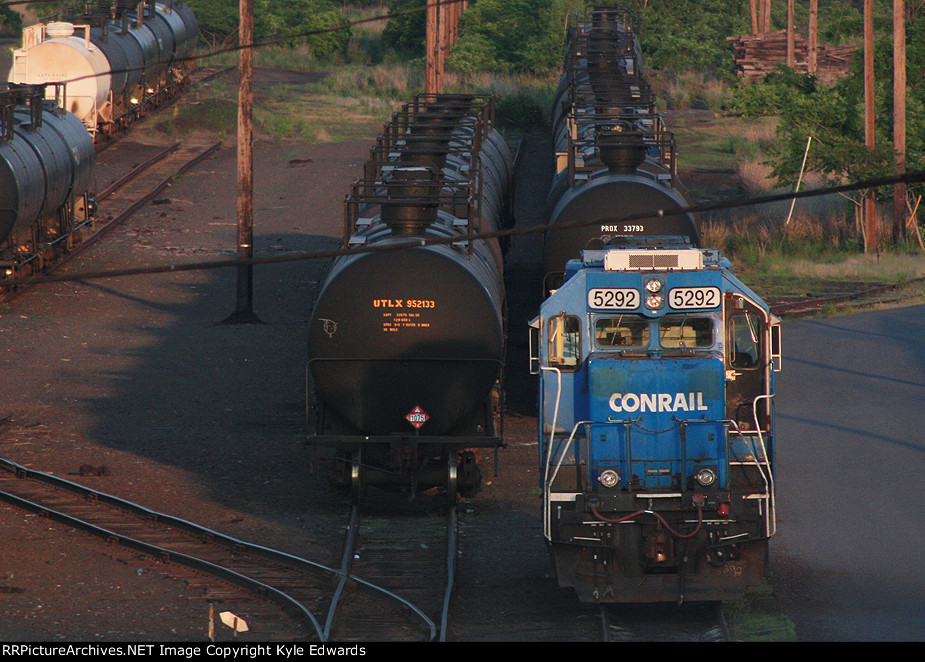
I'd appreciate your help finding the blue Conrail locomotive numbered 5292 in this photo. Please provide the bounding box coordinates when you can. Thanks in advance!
[531,244,780,602]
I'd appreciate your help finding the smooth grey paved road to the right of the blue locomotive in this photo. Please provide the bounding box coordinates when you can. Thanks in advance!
[772,306,925,641]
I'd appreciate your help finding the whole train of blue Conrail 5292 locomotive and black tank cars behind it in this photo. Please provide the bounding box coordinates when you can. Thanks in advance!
[530,8,780,602]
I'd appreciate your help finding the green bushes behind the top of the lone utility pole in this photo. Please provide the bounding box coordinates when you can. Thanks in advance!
[186,0,350,59]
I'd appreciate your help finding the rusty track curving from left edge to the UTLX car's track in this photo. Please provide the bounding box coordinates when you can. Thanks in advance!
[0,458,336,641]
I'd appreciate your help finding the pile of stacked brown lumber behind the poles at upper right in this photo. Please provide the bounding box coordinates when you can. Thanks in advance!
[726,30,857,82]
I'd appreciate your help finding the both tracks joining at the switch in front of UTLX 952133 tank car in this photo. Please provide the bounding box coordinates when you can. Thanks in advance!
[0,458,456,641]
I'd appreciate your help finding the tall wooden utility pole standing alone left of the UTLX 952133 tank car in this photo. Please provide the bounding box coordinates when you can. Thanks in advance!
[225,0,260,324]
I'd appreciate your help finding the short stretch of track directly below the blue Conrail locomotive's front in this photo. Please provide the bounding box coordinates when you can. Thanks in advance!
[600,602,731,642]
